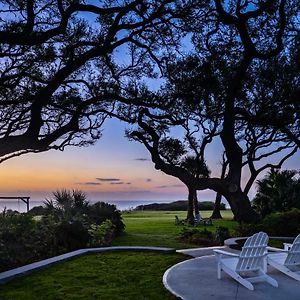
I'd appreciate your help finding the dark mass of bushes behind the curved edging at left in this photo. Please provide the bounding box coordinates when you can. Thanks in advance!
[0,190,125,272]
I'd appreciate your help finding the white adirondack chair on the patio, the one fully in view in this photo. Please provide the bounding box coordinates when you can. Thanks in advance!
[214,232,278,290]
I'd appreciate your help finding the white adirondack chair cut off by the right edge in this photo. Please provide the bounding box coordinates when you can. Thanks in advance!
[267,234,300,281]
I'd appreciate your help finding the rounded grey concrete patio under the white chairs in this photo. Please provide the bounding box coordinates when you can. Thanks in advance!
[163,252,300,300]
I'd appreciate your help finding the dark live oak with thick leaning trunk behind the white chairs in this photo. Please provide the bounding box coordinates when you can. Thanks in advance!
[127,0,300,222]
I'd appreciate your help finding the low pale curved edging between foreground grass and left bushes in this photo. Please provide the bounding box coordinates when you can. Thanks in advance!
[0,246,176,284]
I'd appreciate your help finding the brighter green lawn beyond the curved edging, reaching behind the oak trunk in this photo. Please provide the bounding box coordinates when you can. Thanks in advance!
[113,210,237,249]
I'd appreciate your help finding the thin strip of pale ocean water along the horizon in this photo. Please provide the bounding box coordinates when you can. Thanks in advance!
[0,199,172,212]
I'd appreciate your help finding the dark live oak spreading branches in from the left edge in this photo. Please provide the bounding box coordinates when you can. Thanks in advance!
[0,0,183,162]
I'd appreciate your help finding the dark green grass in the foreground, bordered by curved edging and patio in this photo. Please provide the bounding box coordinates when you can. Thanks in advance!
[0,252,186,300]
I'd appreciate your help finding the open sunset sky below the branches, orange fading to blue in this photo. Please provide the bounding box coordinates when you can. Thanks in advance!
[0,116,300,205]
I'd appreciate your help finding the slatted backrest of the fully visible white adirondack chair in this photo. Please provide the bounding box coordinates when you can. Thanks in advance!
[236,232,269,272]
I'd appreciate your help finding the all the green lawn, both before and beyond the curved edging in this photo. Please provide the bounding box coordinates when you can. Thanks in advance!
[0,211,237,300]
